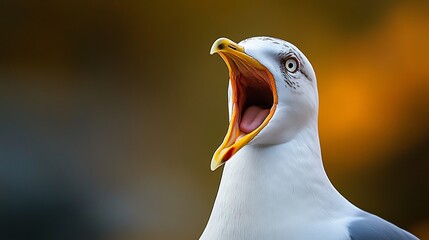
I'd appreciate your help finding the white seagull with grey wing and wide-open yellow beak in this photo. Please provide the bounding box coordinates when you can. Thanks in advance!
[200,37,418,240]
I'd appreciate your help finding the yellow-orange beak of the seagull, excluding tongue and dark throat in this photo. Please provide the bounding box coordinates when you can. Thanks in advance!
[210,38,278,170]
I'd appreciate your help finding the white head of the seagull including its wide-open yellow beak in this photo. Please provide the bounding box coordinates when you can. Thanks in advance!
[210,37,318,170]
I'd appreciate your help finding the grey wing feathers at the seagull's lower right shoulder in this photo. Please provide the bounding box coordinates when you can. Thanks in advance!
[348,211,418,240]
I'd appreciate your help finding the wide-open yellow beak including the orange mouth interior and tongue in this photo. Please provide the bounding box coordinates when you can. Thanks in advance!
[210,38,278,170]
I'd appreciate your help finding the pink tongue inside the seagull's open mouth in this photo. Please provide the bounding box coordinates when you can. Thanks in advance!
[240,106,270,134]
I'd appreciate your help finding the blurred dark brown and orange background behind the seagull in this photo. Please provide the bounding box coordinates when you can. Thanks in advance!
[0,0,429,240]
